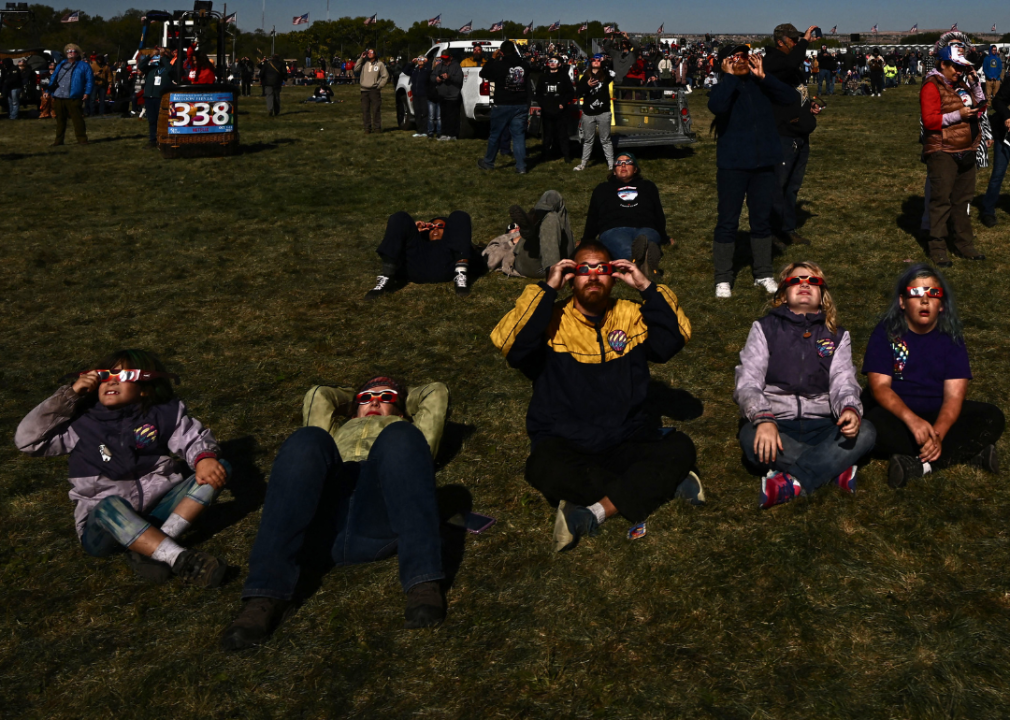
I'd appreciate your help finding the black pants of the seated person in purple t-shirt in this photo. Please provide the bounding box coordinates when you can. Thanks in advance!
[863,392,1006,468]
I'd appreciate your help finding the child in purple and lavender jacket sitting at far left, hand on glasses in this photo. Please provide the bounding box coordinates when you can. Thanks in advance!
[14,350,228,588]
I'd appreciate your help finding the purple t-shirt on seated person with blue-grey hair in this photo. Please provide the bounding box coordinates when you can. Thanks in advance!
[863,323,972,414]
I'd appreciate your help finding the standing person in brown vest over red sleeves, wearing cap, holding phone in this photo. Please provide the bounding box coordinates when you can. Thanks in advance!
[919,44,986,268]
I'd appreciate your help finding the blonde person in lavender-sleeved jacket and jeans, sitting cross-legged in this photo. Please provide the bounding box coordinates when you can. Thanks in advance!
[733,263,876,510]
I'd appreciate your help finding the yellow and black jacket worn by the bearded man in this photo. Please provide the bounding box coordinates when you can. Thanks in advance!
[491,282,691,452]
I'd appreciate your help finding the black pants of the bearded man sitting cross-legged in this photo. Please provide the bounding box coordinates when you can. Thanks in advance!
[526,430,695,522]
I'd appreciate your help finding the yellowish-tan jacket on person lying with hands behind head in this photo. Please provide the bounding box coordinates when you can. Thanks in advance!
[302,383,448,462]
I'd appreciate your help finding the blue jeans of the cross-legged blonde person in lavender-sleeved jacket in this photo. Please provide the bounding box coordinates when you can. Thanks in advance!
[739,418,877,493]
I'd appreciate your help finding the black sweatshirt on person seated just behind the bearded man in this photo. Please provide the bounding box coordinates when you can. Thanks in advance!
[582,175,669,241]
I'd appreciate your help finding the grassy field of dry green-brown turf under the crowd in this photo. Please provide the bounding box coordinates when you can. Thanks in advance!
[0,87,1010,720]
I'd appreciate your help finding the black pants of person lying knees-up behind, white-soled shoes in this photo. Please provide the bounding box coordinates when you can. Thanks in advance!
[379,210,473,283]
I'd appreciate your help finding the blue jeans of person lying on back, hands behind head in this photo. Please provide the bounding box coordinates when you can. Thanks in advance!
[242,422,445,600]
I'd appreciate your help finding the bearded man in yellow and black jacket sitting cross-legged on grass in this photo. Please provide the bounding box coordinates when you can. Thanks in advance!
[491,240,704,550]
